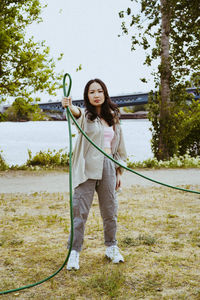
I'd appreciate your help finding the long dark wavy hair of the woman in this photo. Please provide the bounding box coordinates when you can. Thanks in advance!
[83,78,119,126]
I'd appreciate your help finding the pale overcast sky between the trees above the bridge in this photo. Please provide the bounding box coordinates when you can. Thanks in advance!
[27,0,158,102]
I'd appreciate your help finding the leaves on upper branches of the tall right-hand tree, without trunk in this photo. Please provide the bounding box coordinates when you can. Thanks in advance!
[119,0,200,87]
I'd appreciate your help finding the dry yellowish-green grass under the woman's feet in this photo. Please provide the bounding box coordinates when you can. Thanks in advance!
[0,186,200,300]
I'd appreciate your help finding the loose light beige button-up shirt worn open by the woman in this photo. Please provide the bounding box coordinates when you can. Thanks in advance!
[67,108,127,188]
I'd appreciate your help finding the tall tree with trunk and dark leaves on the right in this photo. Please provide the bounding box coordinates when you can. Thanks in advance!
[119,0,200,159]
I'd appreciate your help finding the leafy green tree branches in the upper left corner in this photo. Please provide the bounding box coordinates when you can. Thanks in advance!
[0,0,62,101]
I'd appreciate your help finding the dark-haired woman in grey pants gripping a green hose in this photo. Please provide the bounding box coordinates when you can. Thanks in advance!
[62,79,126,270]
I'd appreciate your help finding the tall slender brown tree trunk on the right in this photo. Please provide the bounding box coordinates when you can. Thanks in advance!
[158,0,171,160]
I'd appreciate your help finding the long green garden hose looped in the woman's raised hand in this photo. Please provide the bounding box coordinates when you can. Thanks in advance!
[0,73,200,295]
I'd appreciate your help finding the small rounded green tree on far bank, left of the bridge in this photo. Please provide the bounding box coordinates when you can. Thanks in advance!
[2,97,48,122]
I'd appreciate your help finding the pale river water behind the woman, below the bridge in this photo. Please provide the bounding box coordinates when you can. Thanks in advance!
[0,119,153,165]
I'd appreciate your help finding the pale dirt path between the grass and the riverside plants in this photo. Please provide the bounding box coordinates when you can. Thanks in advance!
[0,169,200,193]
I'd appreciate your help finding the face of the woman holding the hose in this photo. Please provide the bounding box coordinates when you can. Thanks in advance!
[88,82,105,107]
